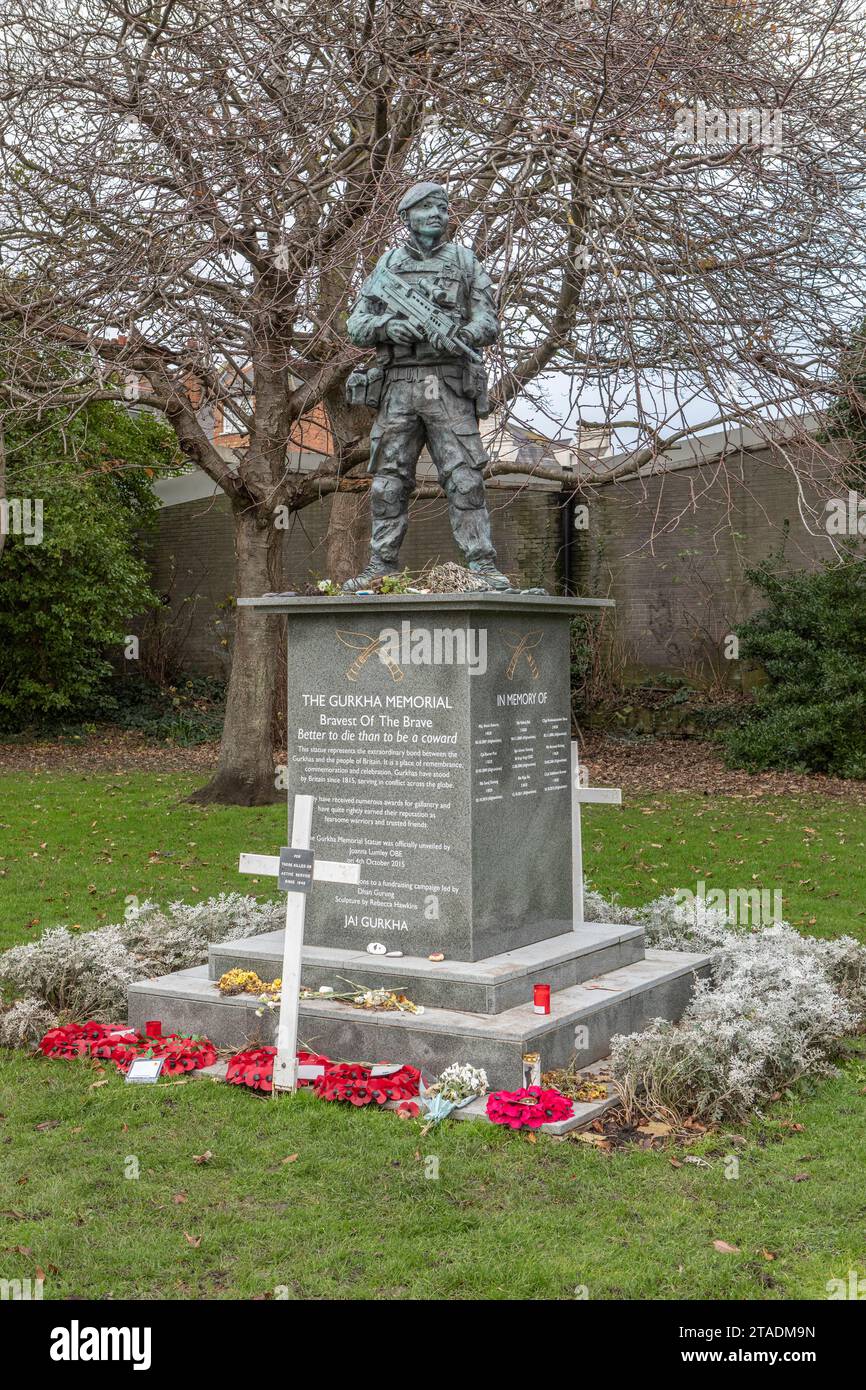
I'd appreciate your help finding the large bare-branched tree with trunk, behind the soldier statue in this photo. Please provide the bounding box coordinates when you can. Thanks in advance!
[0,0,866,803]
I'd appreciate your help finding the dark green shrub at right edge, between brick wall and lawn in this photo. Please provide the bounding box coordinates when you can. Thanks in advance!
[726,552,866,777]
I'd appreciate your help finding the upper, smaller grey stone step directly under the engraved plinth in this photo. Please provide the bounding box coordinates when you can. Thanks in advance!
[209,922,644,1013]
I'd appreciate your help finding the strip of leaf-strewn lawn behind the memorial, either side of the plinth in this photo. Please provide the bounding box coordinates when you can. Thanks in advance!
[0,773,866,949]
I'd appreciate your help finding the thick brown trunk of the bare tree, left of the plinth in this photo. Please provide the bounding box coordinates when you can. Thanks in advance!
[189,500,285,806]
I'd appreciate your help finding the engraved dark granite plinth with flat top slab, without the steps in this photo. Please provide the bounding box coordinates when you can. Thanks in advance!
[239,594,608,962]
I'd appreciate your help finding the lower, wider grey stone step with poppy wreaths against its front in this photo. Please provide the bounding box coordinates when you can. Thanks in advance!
[129,951,709,1090]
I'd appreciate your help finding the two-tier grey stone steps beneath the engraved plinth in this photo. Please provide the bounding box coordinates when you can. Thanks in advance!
[129,923,709,1090]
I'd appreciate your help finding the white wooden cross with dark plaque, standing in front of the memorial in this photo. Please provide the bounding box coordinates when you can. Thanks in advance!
[238,795,361,1095]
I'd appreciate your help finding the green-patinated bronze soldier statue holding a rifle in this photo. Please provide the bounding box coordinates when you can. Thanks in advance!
[343,182,510,594]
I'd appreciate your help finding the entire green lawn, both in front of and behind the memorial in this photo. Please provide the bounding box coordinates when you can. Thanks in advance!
[0,773,866,1300]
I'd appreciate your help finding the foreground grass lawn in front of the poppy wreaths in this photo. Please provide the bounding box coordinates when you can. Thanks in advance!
[0,1059,866,1300]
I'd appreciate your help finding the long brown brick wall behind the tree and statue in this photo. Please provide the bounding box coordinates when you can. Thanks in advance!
[143,433,833,680]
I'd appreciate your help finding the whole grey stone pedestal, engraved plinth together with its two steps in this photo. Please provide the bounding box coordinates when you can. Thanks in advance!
[129,594,708,1088]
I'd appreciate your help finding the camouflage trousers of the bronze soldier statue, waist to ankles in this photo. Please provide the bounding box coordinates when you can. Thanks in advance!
[368,366,496,564]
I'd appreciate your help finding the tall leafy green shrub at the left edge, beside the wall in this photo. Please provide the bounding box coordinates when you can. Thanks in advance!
[0,402,177,731]
